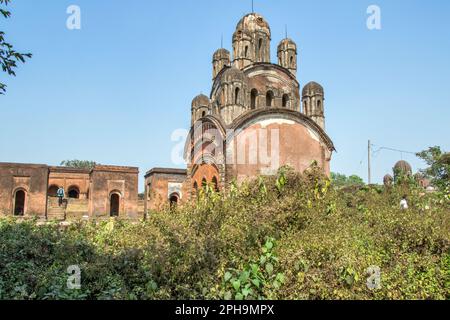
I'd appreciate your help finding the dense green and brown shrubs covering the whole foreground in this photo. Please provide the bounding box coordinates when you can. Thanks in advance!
[0,168,450,299]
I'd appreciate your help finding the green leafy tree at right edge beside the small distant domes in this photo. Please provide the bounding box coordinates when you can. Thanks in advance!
[417,146,450,190]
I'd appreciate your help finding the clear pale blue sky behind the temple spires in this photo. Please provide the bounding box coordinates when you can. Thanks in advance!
[0,0,450,189]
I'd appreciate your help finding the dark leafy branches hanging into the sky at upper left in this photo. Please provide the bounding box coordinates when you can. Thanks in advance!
[0,0,32,94]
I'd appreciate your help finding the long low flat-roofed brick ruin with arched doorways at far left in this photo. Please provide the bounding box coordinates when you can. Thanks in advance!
[0,163,139,220]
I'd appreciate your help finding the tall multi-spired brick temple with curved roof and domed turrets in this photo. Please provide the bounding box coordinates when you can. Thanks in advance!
[185,13,334,201]
